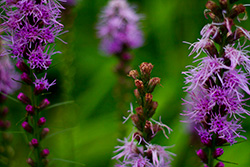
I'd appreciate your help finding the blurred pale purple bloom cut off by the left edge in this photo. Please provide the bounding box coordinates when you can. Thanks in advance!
[0,56,20,94]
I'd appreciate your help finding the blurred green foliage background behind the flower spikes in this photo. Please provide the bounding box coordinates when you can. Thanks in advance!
[2,0,250,167]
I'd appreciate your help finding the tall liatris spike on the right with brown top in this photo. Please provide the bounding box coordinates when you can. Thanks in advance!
[182,0,250,167]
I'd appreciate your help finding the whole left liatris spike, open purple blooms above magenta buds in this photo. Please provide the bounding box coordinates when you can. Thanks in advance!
[1,0,63,167]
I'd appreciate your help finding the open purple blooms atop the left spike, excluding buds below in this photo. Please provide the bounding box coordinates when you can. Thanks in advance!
[1,0,63,70]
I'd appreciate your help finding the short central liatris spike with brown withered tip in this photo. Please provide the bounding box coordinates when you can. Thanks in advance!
[113,63,175,167]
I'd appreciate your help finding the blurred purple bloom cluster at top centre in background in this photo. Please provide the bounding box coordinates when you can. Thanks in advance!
[97,0,143,54]
